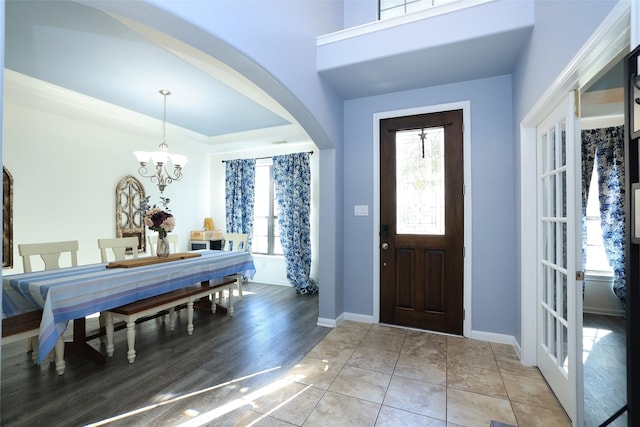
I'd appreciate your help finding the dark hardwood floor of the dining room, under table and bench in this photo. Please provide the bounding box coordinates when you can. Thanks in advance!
[0,283,330,426]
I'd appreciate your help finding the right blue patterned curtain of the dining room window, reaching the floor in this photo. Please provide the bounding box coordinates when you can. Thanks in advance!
[273,153,318,294]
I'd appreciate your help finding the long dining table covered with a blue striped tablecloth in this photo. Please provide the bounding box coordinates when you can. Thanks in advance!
[2,250,256,364]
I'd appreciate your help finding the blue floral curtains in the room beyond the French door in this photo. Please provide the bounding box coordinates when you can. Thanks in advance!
[582,126,627,304]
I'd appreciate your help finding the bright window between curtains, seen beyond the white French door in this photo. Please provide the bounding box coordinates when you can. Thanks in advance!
[585,166,613,275]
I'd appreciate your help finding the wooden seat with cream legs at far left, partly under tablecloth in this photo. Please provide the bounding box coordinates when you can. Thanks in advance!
[2,310,65,375]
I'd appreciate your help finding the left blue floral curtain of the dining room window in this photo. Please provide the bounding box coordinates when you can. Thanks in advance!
[225,159,256,250]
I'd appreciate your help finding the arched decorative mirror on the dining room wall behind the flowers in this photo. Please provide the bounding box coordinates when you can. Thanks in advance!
[116,175,147,253]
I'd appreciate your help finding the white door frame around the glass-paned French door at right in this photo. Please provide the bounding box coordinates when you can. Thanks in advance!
[520,1,630,366]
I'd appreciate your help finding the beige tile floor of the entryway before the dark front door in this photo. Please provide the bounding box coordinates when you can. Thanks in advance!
[227,322,571,427]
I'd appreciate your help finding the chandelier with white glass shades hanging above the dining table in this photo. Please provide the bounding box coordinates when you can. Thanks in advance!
[133,89,187,193]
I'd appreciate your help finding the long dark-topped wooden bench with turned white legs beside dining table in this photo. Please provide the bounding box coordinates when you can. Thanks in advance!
[105,278,237,363]
